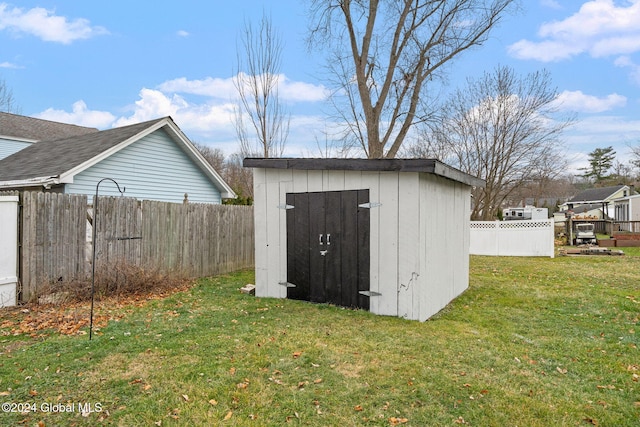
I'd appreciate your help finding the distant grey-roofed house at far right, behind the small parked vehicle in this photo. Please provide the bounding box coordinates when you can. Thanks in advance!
[560,185,634,219]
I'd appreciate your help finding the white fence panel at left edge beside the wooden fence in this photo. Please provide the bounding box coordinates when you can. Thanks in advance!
[0,196,18,307]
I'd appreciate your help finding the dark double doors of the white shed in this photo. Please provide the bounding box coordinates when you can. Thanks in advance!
[287,190,369,310]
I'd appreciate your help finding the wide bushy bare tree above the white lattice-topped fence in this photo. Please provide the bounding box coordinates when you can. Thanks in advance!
[412,67,574,220]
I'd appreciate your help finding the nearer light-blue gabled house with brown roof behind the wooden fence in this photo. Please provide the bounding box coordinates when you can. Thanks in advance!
[0,117,236,203]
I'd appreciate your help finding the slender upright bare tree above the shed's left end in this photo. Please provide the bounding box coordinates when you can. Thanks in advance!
[234,14,290,157]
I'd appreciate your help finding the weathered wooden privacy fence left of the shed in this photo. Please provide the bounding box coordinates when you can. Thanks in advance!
[20,192,254,301]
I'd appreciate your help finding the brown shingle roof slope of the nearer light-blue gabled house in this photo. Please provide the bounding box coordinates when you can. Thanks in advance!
[0,118,165,181]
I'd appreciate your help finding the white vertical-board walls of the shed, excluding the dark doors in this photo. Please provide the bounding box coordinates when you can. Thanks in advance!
[254,168,470,321]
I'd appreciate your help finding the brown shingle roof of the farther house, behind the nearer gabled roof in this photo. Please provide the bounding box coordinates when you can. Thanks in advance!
[0,112,98,141]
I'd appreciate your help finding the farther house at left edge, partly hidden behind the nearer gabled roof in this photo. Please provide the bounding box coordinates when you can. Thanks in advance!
[0,112,98,159]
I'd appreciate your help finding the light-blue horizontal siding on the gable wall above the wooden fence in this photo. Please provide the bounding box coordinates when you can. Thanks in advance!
[65,129,221,203]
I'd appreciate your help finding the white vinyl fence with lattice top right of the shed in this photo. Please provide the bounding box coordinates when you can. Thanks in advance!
[469,220,554,258]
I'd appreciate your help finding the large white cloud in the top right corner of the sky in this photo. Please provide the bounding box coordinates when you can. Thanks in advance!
[509,0,640,62]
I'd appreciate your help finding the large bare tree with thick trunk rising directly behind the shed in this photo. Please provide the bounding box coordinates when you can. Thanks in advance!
[309,0,513,158]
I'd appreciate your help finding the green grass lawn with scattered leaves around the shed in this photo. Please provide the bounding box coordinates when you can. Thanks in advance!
[0,252,640,427]
